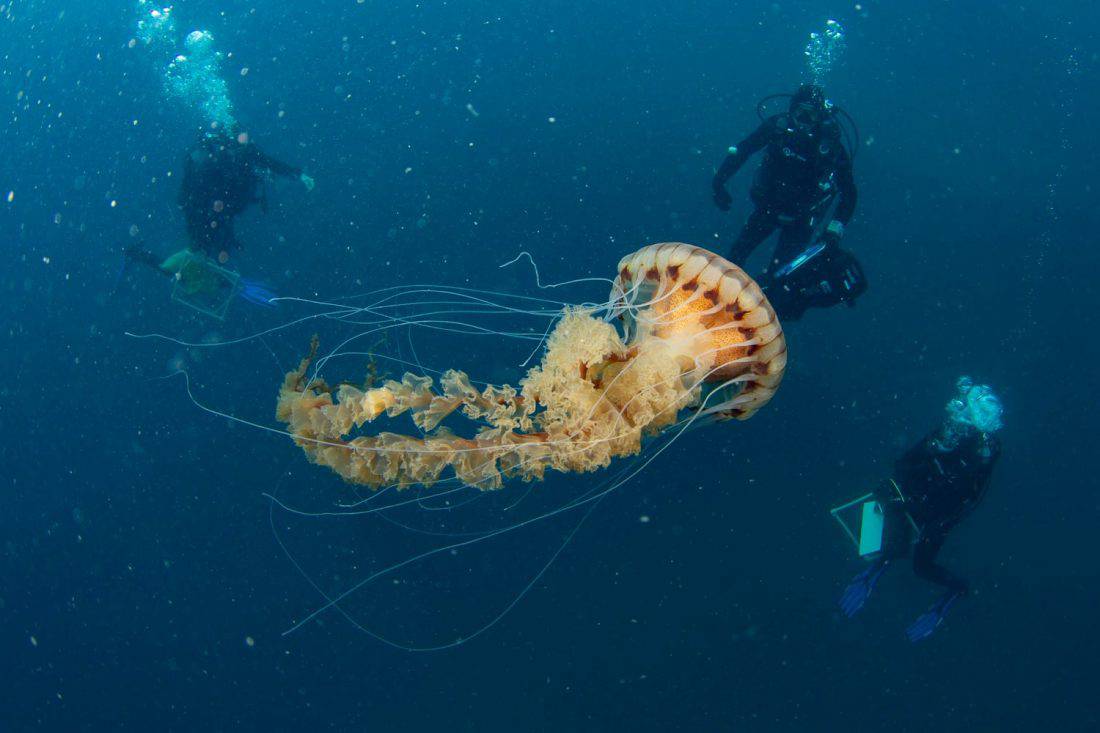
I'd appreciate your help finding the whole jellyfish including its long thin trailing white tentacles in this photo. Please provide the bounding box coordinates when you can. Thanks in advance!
[126,243,787,650]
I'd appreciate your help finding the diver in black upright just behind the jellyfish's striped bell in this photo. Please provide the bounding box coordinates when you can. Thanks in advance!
[712,84,867,320]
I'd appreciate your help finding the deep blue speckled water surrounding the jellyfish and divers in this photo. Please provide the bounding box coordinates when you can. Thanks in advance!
[0,0,1100,731]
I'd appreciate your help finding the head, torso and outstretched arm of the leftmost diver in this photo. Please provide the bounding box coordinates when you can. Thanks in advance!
[179,134,314,258]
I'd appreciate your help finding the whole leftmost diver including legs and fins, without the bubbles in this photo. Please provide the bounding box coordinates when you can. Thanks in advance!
[119,132,314,318]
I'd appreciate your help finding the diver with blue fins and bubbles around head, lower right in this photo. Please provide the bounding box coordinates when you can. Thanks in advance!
[840,376,1003,642]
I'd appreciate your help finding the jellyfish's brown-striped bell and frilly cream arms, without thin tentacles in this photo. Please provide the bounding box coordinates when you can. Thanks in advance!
[276,243,787,491]
